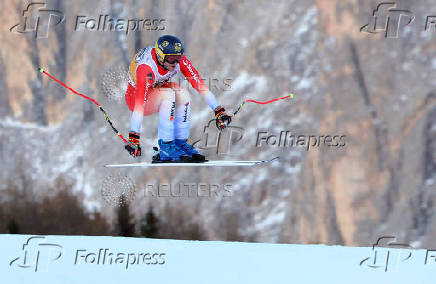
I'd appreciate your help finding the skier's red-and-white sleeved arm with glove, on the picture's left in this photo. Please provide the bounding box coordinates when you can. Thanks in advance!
[125,64,154,157]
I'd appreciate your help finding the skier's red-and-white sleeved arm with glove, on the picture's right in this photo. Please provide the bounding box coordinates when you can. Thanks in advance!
[179,55,232,130]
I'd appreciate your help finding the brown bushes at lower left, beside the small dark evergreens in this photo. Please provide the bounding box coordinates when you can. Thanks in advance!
[0,177,113,236]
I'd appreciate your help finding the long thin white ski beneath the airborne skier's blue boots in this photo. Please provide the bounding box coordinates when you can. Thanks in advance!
[105,157,279,168]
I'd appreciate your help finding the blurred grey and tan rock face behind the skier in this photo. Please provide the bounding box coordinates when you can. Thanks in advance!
[0,0,436,247]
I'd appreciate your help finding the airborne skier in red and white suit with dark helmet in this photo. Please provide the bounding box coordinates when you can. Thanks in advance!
[125,35,231,162]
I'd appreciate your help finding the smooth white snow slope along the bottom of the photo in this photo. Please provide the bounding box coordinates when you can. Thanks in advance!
[0,235,436,284]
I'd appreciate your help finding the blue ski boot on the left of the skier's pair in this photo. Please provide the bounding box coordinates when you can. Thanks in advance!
[152,139,191,163]
